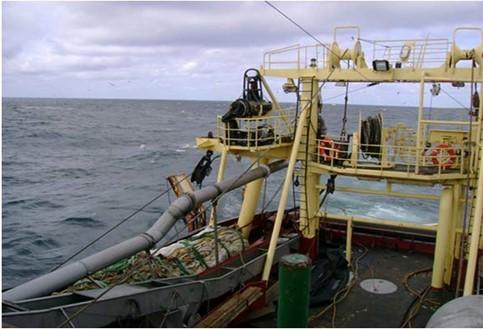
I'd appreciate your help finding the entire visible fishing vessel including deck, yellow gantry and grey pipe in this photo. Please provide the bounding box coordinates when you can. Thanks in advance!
[3,22,483,327]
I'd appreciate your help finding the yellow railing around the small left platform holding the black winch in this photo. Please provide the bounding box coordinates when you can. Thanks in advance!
[217,110,295,148]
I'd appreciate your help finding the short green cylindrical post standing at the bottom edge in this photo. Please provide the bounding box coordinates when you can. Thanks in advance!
[277,254,311,328]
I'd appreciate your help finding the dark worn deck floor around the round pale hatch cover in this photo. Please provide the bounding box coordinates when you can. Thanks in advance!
[244,247,454,328]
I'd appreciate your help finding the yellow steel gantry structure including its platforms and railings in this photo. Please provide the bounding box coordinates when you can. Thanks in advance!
[197,27,483,295]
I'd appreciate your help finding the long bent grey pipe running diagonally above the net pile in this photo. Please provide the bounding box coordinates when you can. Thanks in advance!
[3,160,287,302]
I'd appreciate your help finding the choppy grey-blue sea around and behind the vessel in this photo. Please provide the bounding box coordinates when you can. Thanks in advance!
[2,98,451,289]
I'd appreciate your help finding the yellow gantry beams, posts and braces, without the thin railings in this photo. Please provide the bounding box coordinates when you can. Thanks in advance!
[197,26,483,295]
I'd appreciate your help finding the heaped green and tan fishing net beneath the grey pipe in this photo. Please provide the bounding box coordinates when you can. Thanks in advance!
[58,227,248,292]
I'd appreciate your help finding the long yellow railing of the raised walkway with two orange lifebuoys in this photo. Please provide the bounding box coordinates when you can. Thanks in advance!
[311,135,475,175]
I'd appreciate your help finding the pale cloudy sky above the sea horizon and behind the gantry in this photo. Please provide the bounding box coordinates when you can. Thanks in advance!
[2,1,483,106]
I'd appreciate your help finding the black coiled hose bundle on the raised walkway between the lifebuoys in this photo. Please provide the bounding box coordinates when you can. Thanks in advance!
[360,113,382,159]
